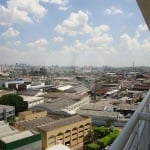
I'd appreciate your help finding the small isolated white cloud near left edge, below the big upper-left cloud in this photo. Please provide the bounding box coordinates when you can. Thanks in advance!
[1,27,20,38]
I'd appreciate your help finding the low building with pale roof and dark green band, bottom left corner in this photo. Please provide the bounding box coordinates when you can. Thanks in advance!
[0,122,41,150]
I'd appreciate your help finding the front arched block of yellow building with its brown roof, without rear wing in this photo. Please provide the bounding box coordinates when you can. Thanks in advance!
[38,115,91,150]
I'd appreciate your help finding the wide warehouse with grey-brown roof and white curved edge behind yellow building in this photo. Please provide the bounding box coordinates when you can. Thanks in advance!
[32,93,91,116]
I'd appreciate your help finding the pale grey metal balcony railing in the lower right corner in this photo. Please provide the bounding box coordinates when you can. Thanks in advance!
[109,91,150,150]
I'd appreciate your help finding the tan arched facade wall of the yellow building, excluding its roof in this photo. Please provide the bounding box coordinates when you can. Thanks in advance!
[39,118,91,150]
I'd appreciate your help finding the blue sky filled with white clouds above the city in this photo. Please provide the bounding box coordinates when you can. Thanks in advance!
[0,0,150,67]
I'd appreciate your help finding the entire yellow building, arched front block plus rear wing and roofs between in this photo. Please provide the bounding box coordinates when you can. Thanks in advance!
[14,111,91,150]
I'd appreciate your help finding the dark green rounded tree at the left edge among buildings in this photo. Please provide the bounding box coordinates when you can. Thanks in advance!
[0,94,27,115]
